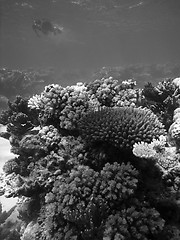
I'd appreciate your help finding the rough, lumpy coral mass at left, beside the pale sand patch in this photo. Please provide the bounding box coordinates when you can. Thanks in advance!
[4,133,83,199]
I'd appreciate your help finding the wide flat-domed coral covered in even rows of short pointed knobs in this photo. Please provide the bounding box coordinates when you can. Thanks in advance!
[78,107,166,149]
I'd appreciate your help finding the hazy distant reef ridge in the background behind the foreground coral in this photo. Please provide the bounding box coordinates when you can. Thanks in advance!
[0,63,180,111]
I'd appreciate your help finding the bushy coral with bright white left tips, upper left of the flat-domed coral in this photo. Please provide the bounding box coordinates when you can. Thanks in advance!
[28,83,88,129]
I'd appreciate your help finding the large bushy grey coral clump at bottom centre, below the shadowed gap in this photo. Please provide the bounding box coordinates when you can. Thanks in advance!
[40,163,137,239]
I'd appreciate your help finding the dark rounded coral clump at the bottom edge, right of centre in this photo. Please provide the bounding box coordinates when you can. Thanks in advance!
[104,203,165,240]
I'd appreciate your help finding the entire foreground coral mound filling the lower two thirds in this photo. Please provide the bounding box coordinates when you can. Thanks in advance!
[0,77,180,240]
